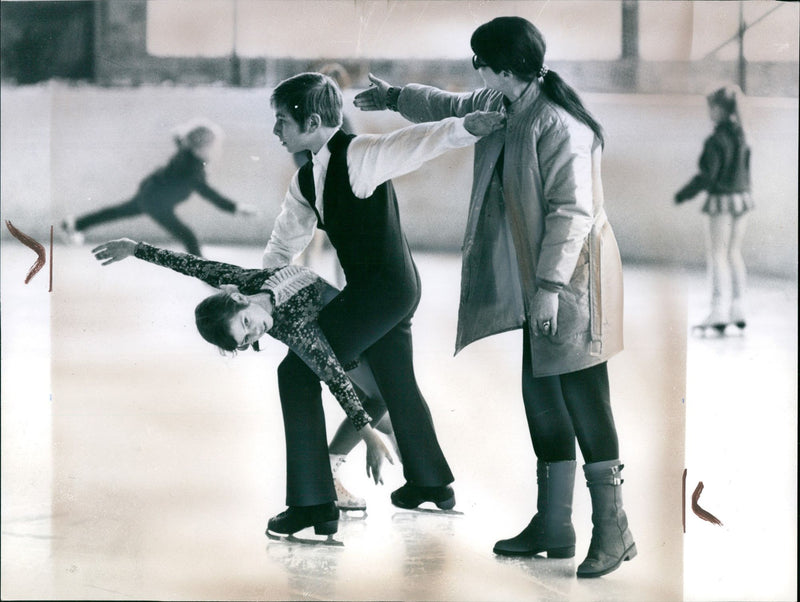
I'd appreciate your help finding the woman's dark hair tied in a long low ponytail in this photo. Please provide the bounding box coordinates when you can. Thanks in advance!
[469,17,604,144]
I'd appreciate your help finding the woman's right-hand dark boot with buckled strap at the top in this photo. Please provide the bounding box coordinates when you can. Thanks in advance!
[578,460,636,577]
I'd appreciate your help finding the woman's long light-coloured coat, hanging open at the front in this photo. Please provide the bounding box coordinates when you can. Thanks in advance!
[398,84,622,377]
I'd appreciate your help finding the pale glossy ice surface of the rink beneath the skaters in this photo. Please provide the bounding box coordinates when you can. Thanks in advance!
[2,241,797,602]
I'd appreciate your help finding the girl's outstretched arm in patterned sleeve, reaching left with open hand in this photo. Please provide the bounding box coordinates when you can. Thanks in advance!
[92,238,250,288]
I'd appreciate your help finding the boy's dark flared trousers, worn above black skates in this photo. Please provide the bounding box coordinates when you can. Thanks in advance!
[278,272,453,506]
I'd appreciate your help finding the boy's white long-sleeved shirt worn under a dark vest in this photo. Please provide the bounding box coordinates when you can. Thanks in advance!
[262,117,479,268]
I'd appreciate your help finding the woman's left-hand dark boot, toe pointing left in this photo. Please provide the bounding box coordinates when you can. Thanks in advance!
[494,460,575,558]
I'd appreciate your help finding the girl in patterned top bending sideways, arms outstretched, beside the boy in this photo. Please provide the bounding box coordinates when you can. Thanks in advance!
[92,238,392,534]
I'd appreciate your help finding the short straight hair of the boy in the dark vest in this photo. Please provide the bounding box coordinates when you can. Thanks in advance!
[270,73,342,131]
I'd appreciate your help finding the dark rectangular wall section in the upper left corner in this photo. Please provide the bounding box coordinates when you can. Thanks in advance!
[0,1,95,84]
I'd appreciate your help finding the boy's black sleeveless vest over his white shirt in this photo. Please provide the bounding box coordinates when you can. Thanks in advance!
[298,130,417,288]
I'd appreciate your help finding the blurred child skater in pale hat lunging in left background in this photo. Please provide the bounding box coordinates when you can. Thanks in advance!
[60,121,256,256]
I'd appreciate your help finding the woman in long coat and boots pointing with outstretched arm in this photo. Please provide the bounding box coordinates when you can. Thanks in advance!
[355,17,636,577]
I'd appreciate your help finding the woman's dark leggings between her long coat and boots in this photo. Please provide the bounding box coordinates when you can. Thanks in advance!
[522,326,619,463]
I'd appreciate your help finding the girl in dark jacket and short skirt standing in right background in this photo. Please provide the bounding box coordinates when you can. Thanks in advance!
[675,85,753,333]
